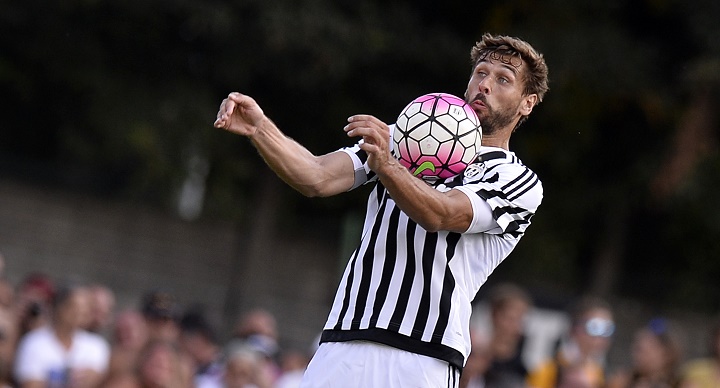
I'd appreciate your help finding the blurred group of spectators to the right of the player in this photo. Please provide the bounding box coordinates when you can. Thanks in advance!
[460,284,720,388]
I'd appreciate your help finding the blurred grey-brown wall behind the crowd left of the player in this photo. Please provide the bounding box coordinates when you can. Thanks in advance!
[0,180,338,349]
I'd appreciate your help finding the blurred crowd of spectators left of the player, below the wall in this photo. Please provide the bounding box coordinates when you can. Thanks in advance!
[0,252,311,388]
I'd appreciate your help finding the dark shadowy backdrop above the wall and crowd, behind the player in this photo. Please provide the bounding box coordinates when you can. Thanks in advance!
[0,0,720,358]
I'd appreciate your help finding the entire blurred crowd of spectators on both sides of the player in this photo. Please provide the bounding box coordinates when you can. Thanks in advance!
[0,249,720,388]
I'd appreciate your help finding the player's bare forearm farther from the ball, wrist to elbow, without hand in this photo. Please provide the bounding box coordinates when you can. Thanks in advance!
[251,118,352,197]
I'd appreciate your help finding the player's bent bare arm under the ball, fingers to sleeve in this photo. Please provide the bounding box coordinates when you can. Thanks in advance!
[345,115,473,233]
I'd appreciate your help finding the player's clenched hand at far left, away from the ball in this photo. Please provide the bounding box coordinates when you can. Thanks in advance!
[213,93,265,136]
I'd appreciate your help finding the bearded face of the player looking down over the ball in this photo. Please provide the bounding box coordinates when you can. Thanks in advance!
[465,53,532,134]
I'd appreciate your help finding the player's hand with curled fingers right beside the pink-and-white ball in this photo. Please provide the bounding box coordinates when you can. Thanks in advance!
[344,115,397,172]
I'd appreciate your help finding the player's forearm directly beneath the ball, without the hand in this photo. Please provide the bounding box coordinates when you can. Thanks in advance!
[377,161,472,233]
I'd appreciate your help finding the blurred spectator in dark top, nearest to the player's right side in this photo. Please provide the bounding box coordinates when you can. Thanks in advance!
[485,283,532,386]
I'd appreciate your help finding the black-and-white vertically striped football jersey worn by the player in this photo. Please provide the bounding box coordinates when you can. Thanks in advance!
[320,141,543,369]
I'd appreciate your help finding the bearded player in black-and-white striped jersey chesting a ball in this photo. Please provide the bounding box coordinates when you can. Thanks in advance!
[215,34,547,387]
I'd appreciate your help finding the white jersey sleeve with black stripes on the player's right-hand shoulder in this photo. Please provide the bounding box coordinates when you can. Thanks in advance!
[455,163,543,238]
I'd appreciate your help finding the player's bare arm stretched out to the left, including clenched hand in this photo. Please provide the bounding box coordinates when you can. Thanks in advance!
[214,93,355,197]
